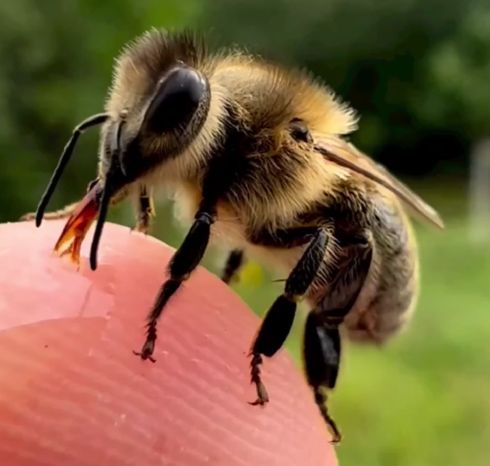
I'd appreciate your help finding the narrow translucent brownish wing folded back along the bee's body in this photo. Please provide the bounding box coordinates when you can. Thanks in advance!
[315,136,444,229]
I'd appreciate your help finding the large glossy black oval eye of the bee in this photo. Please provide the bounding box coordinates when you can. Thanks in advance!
[143,67,208,133]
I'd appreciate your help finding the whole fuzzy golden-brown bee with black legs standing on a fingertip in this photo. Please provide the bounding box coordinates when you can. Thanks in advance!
[28,30,443,442]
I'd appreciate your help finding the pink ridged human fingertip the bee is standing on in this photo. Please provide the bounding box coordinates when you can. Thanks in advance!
[0,221,337,466]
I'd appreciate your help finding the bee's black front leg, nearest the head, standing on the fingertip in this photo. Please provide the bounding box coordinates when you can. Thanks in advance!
[134,209,215,362]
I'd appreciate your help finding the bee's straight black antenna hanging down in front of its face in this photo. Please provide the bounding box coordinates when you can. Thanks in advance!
[90,120,125,270]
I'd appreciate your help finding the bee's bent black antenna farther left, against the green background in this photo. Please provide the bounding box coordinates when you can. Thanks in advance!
[36,113,109,227]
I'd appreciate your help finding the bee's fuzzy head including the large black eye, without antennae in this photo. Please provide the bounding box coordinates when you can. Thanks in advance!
[100,31,211,184]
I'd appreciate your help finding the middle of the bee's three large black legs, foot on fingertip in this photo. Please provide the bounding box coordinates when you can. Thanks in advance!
[250,228,328,405]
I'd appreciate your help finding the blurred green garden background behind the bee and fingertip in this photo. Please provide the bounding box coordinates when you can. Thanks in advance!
[0,0,490,466]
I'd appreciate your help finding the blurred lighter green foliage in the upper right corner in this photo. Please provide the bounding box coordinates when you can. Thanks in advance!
[415,3,490,139]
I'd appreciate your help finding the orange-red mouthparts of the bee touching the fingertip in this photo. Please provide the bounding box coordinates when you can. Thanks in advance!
[54,186,99,264]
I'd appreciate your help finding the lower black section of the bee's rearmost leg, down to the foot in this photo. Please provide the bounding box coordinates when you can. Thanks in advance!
[303,311,341,443]
